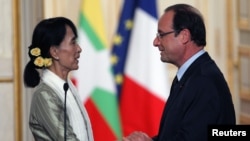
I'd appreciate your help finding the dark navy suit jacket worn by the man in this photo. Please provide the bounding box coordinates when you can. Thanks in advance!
[153,53,236,141]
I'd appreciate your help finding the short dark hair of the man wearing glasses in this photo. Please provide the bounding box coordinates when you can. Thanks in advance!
[165,4,206,46]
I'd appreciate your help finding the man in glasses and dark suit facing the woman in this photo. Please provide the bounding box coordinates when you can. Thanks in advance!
[123,4,236,141]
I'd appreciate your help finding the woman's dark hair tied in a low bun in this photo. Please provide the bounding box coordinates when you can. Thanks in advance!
[24,17,78,87]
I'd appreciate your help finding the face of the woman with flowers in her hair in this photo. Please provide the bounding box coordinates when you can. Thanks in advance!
[57,26,82,72]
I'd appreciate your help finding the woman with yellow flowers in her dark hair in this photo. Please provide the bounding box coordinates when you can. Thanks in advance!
[24,17,93,141]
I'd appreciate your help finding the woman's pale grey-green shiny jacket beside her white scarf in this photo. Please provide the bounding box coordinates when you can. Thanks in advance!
[29,83,93,141]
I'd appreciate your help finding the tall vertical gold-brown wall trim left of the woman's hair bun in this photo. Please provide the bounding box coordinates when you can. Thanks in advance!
[12,0,23,141]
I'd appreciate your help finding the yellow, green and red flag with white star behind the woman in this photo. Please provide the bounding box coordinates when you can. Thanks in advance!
[72,0,122,141]
